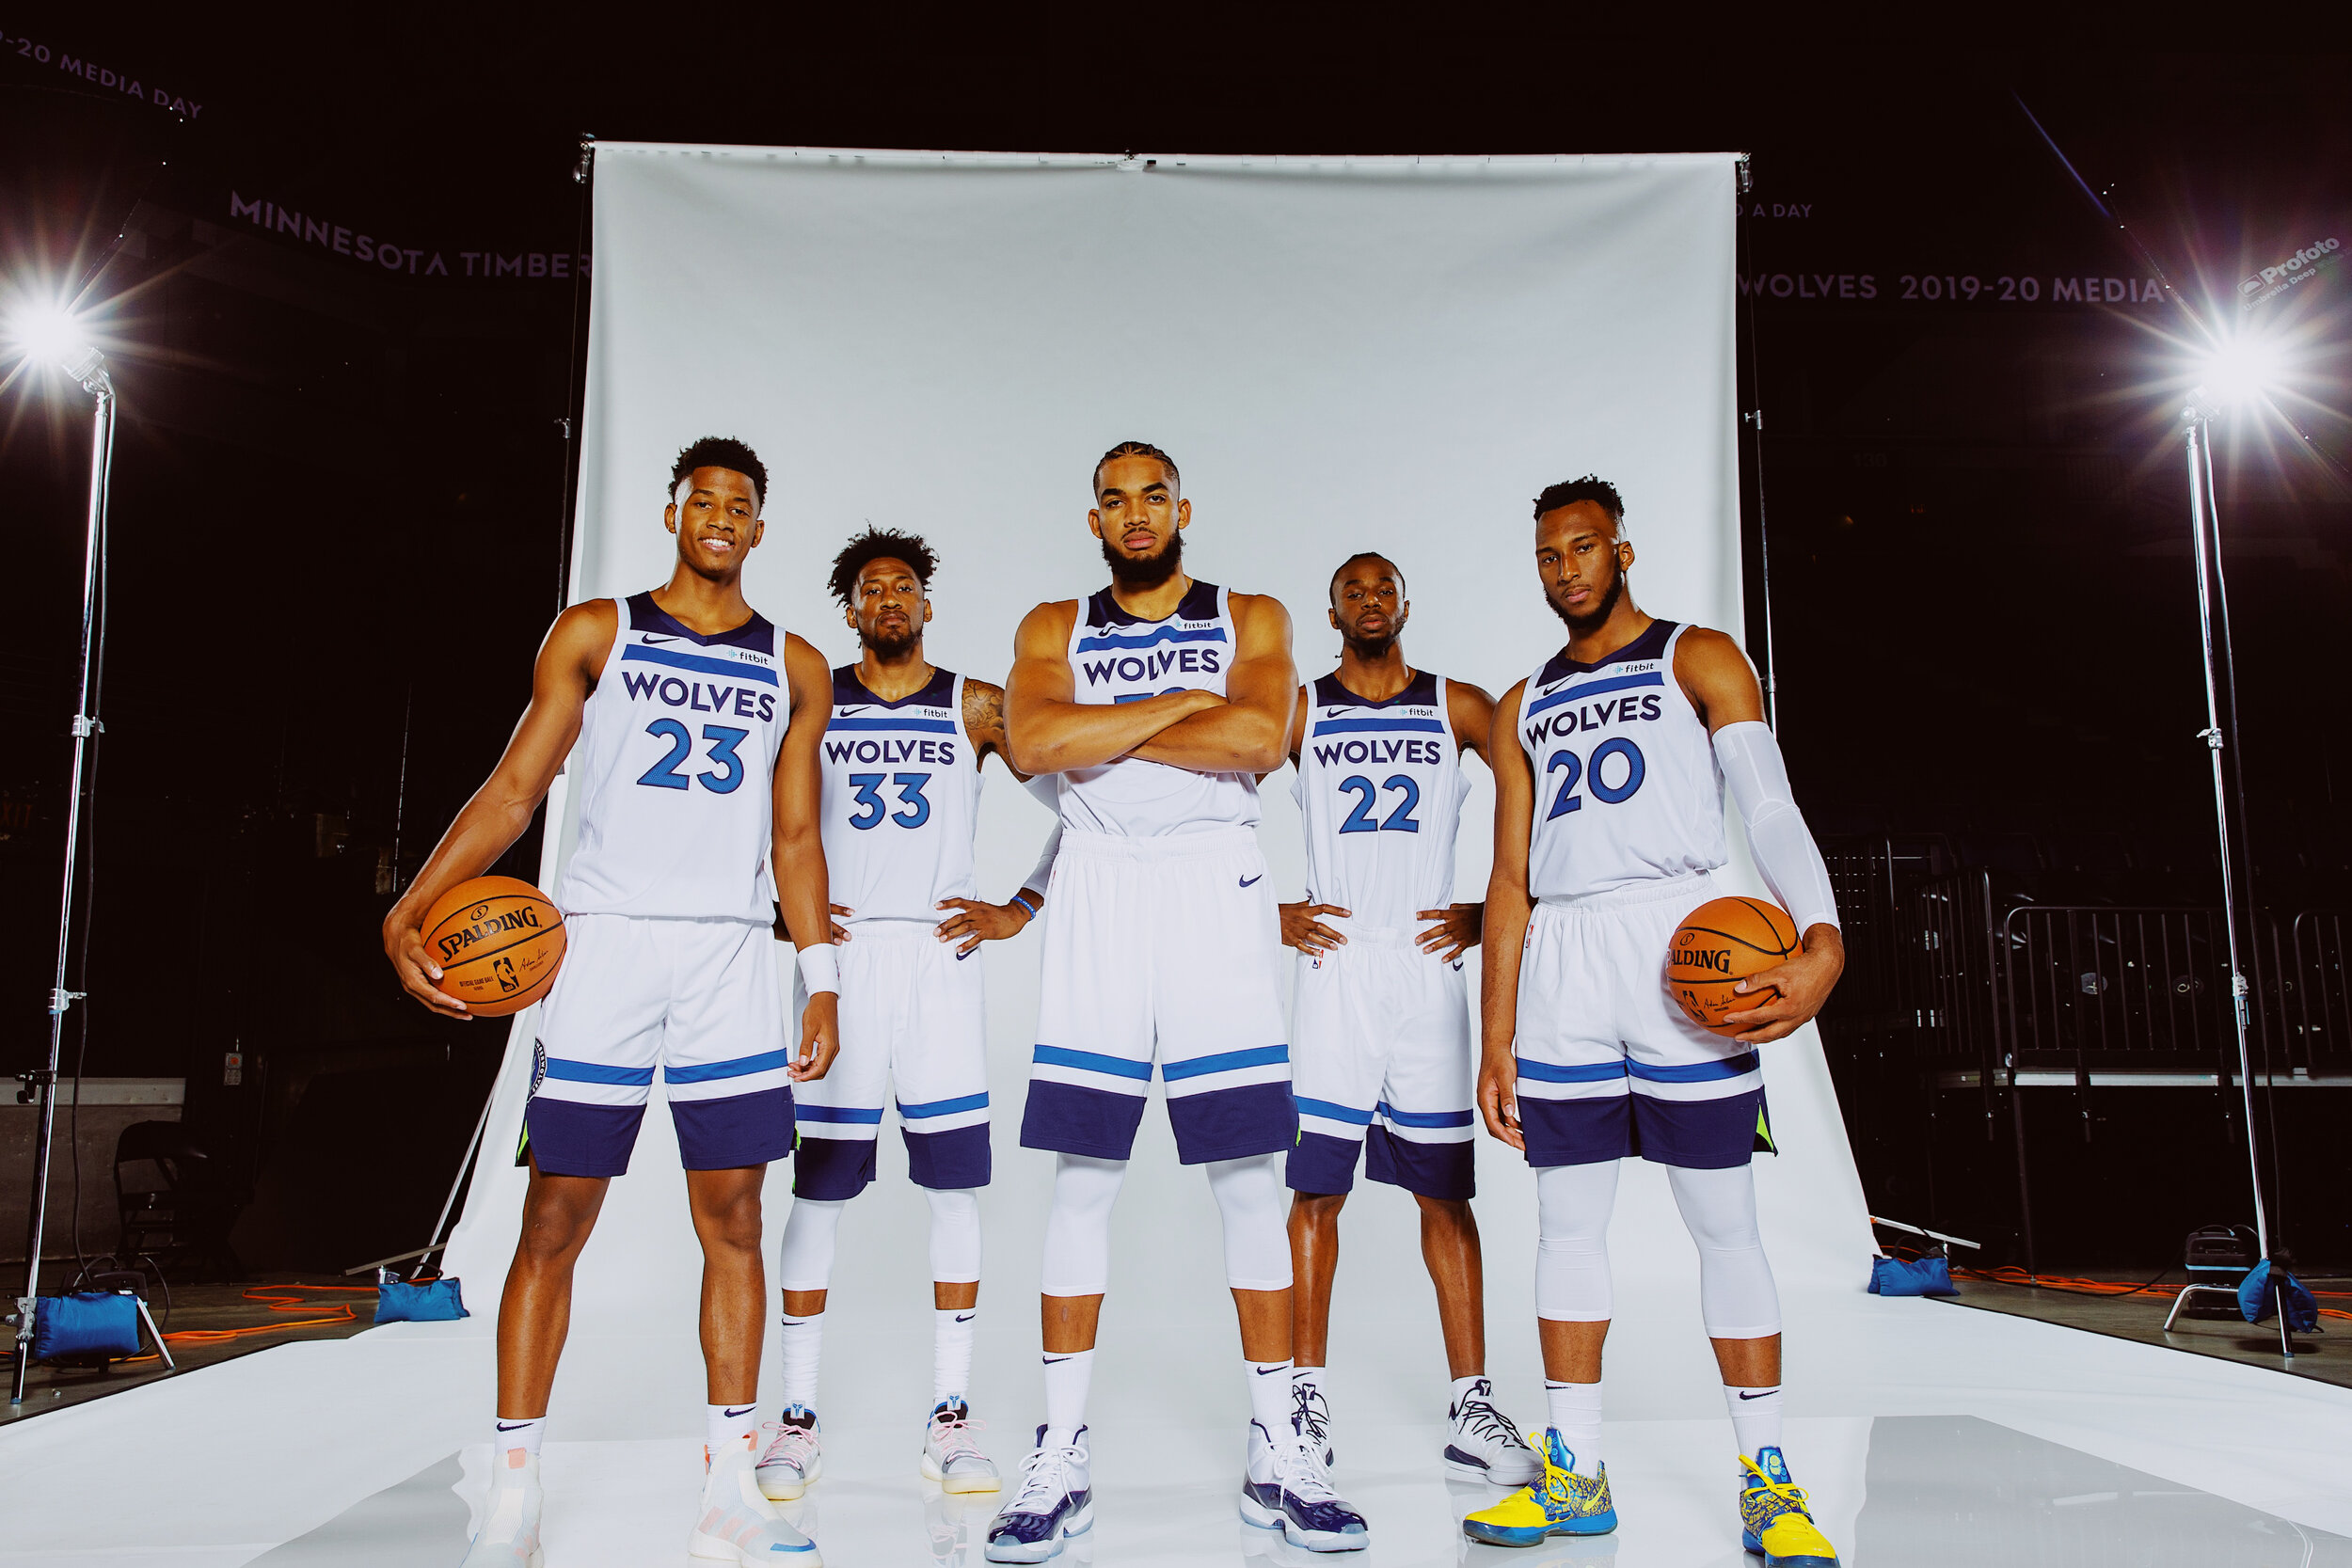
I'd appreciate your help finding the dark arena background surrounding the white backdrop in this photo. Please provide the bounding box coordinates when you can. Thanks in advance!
[0,7,2352,1561]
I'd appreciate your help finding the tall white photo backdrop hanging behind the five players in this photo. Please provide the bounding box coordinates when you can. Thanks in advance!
[450,146,1870,1419]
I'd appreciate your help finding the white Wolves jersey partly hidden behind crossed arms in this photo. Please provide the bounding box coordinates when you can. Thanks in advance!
[1061,583,1259,839]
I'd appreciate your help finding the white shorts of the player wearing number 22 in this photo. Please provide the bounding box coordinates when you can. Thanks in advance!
[1289,914,1477,1199]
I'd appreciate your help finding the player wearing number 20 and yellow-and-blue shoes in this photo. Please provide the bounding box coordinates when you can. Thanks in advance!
[1463,475,1844,1568]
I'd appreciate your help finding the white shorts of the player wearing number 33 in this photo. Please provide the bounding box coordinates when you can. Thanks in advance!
[793,919,988,1199]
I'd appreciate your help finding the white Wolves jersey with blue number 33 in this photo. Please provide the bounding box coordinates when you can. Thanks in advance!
[818,665,981,927]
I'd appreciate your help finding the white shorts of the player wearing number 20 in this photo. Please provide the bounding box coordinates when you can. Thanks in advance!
[1513,872,1772,1171]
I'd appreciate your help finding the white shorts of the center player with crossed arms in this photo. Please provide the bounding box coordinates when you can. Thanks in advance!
[1021,828,1298,1166]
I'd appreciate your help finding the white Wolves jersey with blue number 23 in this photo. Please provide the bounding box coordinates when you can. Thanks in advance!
[555,593,793,927]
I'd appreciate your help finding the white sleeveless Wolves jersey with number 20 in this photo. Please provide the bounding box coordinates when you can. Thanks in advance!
[1519,621,1724,898]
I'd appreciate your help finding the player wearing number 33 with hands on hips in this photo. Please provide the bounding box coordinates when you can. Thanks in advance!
[760,529,1054,1497]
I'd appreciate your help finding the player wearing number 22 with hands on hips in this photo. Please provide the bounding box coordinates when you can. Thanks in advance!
[1282,552,1543,1486]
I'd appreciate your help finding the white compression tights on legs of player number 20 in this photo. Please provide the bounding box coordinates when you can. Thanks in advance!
[1536,1159,1781,1340]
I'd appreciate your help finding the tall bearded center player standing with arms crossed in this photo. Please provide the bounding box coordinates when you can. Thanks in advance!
[988,442,1367,1563]
